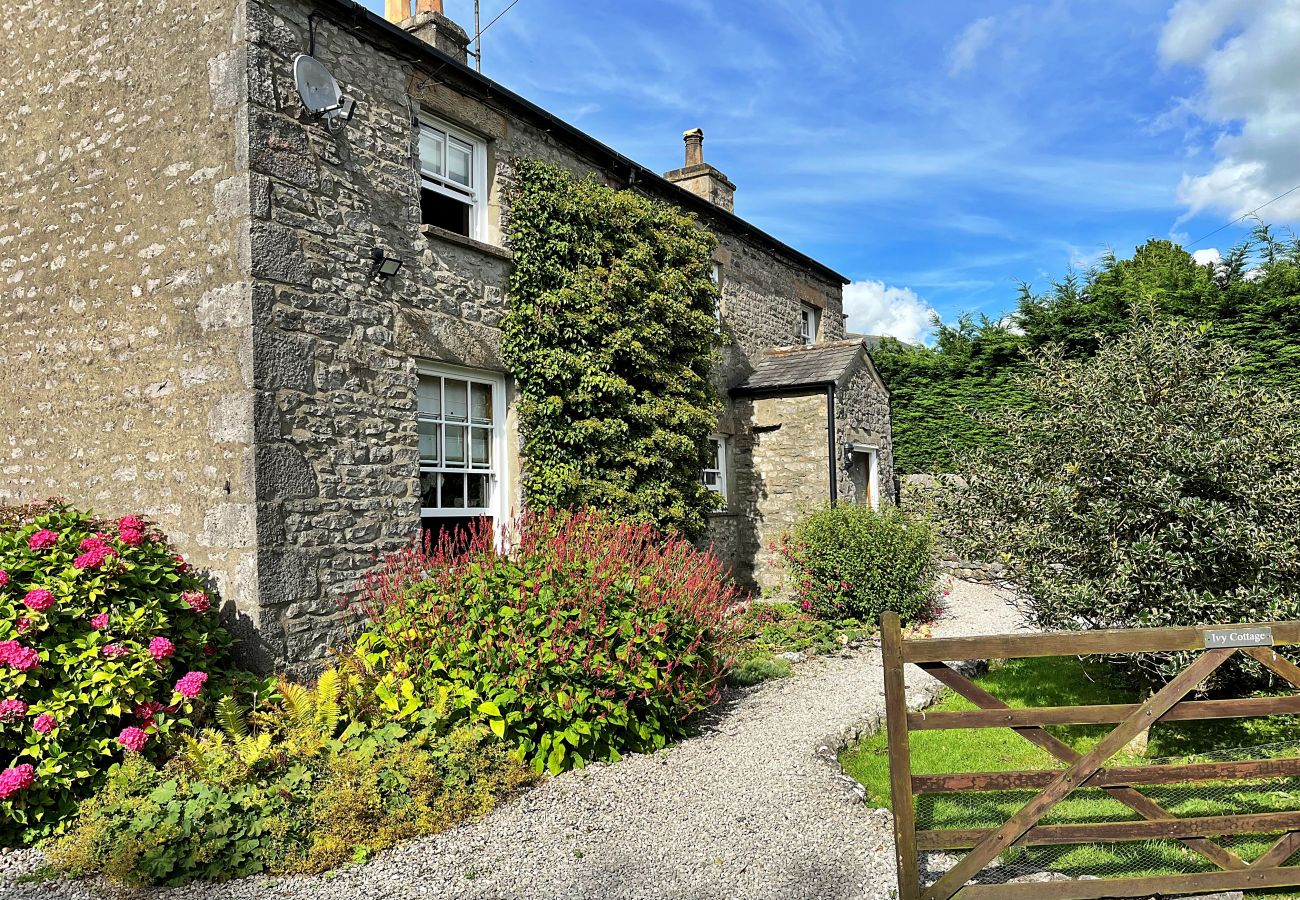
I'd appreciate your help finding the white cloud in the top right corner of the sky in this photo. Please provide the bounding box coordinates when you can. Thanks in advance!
[1160,0,1300,221]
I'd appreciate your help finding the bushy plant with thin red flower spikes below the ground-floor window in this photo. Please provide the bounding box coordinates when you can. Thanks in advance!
[359,511,737,773]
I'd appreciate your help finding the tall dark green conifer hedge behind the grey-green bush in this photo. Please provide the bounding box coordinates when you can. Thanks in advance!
[872,225,1300,472]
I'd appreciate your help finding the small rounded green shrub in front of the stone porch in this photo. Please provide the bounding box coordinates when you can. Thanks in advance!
[781,505,939,624]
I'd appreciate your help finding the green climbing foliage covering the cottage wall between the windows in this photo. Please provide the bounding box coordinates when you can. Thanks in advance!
[502,160,720,537]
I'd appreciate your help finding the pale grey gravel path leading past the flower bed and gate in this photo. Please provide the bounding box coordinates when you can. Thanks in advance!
[0,581,1019,900]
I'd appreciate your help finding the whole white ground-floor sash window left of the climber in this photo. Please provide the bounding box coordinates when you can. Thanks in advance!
[416,363,506,540]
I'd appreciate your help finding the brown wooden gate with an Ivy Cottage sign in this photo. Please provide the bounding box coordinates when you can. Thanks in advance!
[881,613,1300,900]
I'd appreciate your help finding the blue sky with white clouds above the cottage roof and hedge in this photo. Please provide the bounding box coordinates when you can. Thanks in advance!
[367,0,1300,339]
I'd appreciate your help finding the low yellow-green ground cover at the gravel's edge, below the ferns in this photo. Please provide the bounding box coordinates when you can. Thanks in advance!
[48,724,533,884]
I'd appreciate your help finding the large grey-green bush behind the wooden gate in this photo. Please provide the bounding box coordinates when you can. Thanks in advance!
[940,321,1300,680]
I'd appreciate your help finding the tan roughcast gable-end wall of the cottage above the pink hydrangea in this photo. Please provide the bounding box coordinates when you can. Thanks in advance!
[0,0,256,626]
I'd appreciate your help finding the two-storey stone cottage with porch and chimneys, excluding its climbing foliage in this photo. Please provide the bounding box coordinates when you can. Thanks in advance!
[0,0,893,665]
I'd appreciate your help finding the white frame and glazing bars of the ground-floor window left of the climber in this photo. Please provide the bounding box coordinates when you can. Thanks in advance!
[416,362,508,532]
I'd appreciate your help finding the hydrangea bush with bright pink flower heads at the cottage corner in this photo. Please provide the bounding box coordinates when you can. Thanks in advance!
[0,501,229,845]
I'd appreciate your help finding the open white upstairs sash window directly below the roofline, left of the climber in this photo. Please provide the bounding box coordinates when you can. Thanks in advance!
[420,118,488,241]
